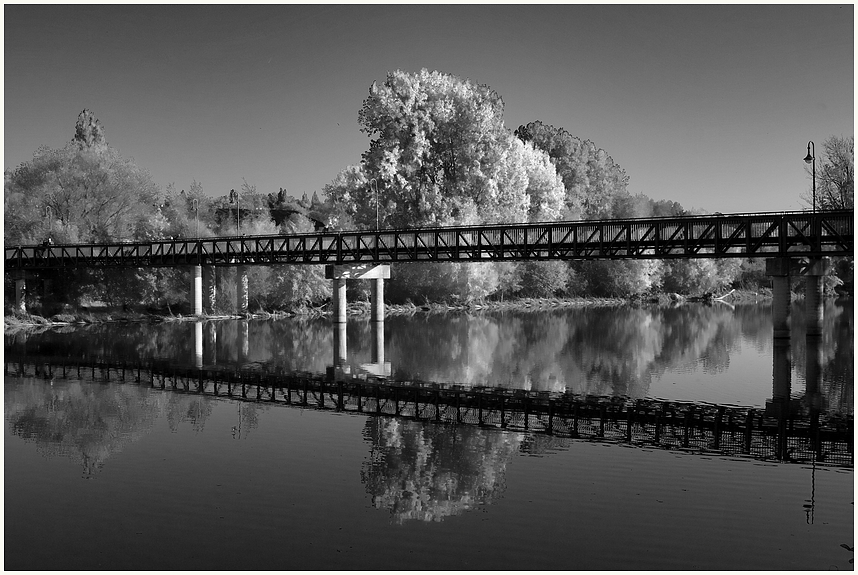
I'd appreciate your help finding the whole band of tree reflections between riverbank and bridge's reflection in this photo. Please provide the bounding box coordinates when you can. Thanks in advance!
[6,301,853,412]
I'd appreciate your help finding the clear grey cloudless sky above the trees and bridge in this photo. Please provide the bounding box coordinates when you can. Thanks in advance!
[4,4,854,213]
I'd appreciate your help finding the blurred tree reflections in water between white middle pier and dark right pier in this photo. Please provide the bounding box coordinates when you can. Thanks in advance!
[388,305,760,397]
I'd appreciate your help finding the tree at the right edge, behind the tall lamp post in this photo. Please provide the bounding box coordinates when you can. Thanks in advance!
[803,136,855,210]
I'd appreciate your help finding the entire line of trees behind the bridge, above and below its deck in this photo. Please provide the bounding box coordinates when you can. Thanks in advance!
[4,70,854,318]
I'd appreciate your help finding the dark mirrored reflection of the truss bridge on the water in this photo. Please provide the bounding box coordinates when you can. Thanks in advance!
[3,354,854,467]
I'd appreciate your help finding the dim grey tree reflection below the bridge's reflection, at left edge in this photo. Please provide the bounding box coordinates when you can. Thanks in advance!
[3,378,213,476]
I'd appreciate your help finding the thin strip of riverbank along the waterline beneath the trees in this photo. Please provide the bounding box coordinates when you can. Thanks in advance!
[3,289,776,332]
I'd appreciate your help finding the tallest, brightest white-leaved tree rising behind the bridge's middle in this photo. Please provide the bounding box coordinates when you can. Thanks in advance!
[353,69,530,226]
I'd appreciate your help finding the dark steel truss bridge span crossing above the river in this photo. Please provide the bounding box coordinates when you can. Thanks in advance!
[5,210,854,271]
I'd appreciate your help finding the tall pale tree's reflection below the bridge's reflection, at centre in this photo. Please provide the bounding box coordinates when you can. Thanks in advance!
[361,416,523,523]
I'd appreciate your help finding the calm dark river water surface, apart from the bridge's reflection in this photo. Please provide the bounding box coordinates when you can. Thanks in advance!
[4,302,854,570]
